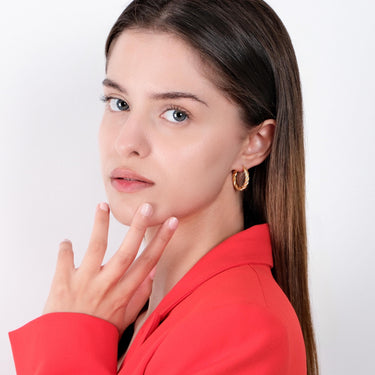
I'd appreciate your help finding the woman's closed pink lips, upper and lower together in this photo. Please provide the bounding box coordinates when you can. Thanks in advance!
[110,168,154,193]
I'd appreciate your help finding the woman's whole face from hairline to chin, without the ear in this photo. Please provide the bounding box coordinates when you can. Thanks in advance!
[99,30,247,225]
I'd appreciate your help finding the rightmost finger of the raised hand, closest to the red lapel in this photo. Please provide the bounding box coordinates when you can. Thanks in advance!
[119,217,178,298]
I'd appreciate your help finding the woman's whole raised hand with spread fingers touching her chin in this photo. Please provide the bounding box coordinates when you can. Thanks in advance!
[43,203,178,334]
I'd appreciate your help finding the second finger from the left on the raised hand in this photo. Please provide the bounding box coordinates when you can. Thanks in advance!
[80,203,109,271]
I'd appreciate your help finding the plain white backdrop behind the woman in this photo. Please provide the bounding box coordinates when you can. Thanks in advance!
[0,0,375,375]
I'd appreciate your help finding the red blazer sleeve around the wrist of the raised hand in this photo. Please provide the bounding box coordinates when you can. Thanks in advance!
[9,313,119,375]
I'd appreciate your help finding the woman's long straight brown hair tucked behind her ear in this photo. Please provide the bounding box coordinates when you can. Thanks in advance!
[105,0,319,375]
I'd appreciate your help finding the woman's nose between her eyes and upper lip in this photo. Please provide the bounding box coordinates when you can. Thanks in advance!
[114,113,151,158]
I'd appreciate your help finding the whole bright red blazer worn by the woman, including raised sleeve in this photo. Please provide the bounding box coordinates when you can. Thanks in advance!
[10,224,306,375]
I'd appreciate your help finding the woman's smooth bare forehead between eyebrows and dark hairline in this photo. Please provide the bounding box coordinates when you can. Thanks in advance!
[107,29,217,94]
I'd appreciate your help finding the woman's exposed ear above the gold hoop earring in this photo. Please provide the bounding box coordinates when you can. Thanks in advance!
[234,119,276,171]
